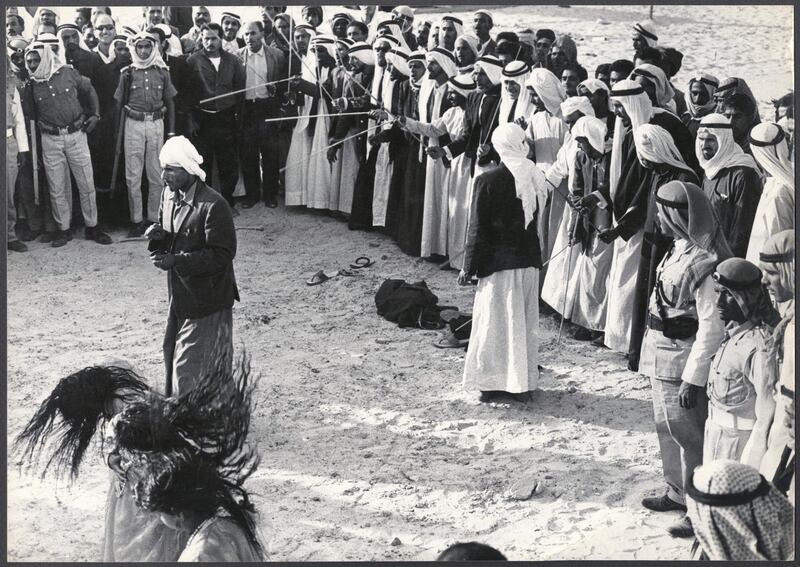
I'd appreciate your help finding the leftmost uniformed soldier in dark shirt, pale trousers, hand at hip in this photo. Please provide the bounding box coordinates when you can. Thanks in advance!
[23,37,111,247]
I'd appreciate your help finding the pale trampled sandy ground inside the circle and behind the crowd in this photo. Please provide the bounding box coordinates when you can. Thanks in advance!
[7,6,792,561]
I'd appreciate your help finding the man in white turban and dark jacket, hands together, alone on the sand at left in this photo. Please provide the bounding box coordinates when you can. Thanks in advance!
[145,136,239,396]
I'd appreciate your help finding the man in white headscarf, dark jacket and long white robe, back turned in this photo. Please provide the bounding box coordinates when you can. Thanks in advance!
[458,123,547,403]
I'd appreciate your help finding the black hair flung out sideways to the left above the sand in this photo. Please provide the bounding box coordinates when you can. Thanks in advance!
[14,366,149,479]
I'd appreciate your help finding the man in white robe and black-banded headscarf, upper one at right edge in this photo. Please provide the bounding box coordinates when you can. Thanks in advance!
[747,122,795,264]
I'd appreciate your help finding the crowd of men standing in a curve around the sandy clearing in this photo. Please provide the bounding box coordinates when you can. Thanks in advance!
[6,6,795,558]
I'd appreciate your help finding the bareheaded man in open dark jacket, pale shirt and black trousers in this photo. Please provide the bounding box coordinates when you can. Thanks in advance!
[239,21,286,209]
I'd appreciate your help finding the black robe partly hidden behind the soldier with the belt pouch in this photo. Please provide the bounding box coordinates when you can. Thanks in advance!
[628,169,698,367]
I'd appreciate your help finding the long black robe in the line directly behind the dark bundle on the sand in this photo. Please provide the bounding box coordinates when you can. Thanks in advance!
[389,81,428,256]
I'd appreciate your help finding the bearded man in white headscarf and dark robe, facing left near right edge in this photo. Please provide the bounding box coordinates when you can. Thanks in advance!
[696,113,762,258]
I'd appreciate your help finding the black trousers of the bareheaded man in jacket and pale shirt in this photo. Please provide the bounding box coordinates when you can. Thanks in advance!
[239,99,281,202]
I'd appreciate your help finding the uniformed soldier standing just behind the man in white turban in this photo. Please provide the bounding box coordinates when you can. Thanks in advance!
[114,32,177,237]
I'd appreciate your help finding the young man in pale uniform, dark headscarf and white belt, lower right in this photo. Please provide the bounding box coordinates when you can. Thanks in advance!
[703,258,777,464]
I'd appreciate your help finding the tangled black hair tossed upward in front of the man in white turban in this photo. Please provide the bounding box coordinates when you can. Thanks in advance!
[119,352,264,555]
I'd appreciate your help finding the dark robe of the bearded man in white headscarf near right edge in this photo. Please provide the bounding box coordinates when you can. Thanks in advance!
[703,167,763,258]
